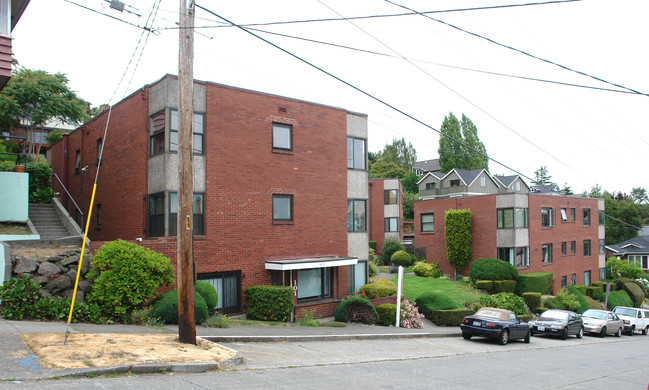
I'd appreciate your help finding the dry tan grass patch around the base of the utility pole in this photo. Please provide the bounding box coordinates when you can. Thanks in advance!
[21,333,236,369]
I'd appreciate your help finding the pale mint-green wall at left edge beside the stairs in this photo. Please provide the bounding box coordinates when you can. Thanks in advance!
[0,172,29,222]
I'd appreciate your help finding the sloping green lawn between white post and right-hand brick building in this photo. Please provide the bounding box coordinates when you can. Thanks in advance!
[392,275,484,304]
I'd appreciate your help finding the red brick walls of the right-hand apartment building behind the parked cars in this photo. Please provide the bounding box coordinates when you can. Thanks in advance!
[415,194,604,292]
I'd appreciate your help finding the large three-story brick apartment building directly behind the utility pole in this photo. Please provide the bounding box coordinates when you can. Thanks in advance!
[50,75,368,316]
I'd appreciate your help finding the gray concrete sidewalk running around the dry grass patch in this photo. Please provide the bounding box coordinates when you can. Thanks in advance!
[0,319,461,380]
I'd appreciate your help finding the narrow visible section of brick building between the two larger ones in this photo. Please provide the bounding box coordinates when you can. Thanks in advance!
[368,179,403,253]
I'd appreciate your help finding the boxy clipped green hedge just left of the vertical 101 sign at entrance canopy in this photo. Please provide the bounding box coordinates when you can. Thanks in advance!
[244,286,293,321]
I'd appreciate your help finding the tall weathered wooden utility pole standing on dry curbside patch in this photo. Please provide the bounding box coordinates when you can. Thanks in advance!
[176,0,196,345]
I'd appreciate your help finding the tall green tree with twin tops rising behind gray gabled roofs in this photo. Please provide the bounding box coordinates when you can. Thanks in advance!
[437,112,489,172]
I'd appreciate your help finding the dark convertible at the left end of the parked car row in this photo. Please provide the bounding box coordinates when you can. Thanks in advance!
[460,307,531,345]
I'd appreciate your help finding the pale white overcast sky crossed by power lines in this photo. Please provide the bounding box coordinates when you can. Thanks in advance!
[12,0,649,193]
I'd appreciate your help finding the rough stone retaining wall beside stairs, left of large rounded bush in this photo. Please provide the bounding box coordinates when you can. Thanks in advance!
[11,249,92,302]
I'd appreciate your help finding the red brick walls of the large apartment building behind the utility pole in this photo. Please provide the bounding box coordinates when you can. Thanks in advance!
[51,76,366,316]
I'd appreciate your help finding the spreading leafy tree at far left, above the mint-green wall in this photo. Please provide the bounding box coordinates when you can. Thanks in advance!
[0,67,88,157]
